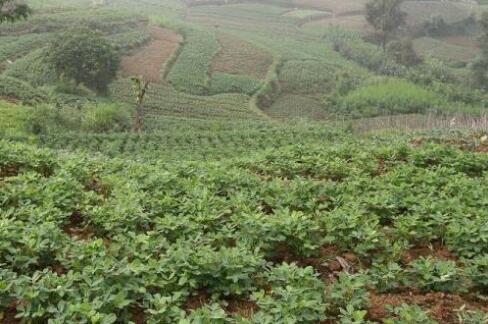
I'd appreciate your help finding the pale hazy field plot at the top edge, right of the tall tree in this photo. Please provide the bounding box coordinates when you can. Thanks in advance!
[402,1,473,26]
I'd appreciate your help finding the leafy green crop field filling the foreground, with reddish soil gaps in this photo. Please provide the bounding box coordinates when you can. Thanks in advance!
[0,136,488,324]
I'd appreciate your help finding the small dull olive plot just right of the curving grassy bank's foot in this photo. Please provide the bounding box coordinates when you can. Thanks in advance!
[264,94,327,120]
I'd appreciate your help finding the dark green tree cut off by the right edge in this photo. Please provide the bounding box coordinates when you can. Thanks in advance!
[471,11,488,89]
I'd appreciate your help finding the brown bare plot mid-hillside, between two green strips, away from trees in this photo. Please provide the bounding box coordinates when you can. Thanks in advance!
[211,34,273,79]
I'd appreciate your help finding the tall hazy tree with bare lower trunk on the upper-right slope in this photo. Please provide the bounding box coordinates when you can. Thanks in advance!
[366,0,406,51]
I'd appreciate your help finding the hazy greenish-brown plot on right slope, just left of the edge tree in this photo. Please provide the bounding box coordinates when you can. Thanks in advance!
[413,37,479,62]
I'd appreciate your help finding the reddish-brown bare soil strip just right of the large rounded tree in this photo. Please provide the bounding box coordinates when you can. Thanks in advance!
[121,26,183,83]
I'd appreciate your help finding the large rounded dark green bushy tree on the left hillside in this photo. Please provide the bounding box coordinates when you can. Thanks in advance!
[46,28,120,94]
